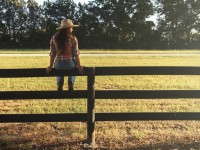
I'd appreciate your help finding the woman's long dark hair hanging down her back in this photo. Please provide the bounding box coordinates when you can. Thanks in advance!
[55,29,69,54]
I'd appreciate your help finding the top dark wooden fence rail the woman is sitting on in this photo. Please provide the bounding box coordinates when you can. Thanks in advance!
[0,66,200,78]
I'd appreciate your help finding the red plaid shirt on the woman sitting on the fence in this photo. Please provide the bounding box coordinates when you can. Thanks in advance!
[49,35,80,60]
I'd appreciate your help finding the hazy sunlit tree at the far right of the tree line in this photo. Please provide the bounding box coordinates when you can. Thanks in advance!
[157,0,200,48]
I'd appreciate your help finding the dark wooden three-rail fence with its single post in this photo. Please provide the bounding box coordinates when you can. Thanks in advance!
[0,66,200,145]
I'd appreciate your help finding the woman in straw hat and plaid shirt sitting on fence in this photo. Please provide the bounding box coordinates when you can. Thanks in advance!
[46,19,83,91]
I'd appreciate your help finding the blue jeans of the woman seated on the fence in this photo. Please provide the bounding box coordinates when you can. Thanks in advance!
[54,60,76,86]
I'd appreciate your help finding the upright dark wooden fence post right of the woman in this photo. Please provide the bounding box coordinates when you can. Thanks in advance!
[87,68,95,146]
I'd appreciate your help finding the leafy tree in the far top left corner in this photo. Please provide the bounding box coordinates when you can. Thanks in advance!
[1,0,26,42]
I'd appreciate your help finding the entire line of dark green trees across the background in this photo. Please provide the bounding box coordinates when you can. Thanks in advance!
[0,0,200,49]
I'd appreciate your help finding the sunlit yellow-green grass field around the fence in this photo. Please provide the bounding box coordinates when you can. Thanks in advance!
[0,50,200,150]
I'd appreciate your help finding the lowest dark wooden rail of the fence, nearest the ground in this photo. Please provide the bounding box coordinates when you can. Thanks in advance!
[0,112,200,123]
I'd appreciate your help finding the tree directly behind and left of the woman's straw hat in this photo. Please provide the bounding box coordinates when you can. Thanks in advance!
[40,0,76,42]
